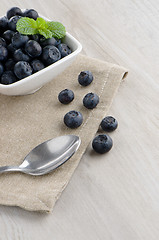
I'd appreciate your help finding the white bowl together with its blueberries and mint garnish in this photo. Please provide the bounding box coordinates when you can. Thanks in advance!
[0,7,82,95]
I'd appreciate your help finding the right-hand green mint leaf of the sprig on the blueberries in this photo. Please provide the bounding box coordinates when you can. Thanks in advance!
[47,22,66,39]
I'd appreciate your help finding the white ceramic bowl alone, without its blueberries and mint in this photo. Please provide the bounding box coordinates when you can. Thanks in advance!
[0,18,82,96]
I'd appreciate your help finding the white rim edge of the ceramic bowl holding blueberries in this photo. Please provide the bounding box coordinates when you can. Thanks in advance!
[0,32,82,89]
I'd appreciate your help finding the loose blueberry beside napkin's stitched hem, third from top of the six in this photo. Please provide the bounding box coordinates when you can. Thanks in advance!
[83,93,99,109]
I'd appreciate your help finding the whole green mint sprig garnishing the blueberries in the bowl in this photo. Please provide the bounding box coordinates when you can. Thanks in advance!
[16,17,66,39]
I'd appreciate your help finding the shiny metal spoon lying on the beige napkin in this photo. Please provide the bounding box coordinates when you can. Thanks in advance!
[0,135,81,175]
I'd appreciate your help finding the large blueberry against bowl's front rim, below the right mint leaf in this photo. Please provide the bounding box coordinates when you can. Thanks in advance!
[42,45,61,65]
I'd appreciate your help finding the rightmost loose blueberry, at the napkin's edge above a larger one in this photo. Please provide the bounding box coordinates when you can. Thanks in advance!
[101,116,118,132]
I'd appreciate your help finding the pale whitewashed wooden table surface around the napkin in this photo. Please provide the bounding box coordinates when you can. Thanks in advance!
[0,0,159,240]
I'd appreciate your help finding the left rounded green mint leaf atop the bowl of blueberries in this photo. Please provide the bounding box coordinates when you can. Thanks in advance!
[16,17,38,35]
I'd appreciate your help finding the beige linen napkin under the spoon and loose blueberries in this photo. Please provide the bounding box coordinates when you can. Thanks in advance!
[0,55,126,212]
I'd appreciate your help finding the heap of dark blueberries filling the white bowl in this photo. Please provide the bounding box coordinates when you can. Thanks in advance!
[0,7,71,84]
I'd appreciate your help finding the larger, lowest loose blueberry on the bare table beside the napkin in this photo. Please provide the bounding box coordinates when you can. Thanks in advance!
[92,134,113,154]
